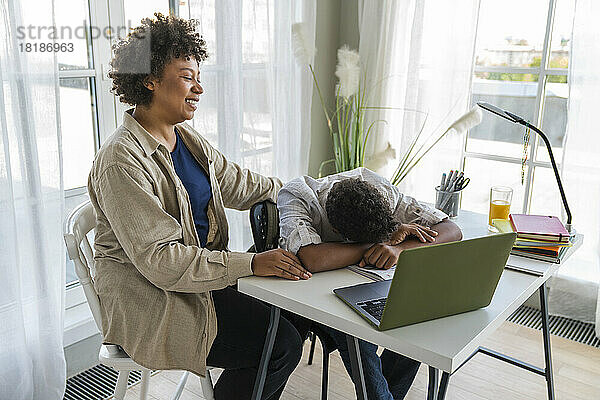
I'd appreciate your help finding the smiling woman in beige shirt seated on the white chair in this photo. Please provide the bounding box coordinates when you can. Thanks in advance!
[88,14,310,399]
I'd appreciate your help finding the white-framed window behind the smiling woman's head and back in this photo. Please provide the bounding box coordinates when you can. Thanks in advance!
[61,0,169,287]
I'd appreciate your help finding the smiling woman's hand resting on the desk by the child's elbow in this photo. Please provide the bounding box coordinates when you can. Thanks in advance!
[252,249,312,281]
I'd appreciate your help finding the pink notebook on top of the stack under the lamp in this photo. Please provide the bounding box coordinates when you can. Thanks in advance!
[510,214,569,242]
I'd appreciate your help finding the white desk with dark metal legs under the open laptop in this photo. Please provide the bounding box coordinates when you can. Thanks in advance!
[238,211,581,399]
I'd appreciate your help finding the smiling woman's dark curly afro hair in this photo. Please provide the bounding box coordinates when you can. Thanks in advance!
[108,13,208,105]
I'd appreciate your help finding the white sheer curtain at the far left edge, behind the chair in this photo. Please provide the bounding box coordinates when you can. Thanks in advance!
[0,0,66,400]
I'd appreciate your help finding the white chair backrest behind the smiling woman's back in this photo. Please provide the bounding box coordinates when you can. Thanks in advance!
[64,201,102,332]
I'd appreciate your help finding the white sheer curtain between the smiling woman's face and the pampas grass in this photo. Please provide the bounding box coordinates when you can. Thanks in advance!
[189,0,316,250]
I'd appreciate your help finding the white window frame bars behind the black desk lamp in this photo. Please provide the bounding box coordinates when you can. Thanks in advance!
[460,0,571,213]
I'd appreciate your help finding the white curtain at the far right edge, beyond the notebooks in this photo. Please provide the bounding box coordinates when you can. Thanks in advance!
[549,0,600,337]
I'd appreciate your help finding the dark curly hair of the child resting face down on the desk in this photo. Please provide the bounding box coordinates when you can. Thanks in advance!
[325,178,398,243]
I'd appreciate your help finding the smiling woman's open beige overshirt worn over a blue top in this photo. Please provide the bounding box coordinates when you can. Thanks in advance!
[88,110,281,375]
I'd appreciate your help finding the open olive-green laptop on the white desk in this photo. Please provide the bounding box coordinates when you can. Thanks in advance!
[333,232,517,331]
